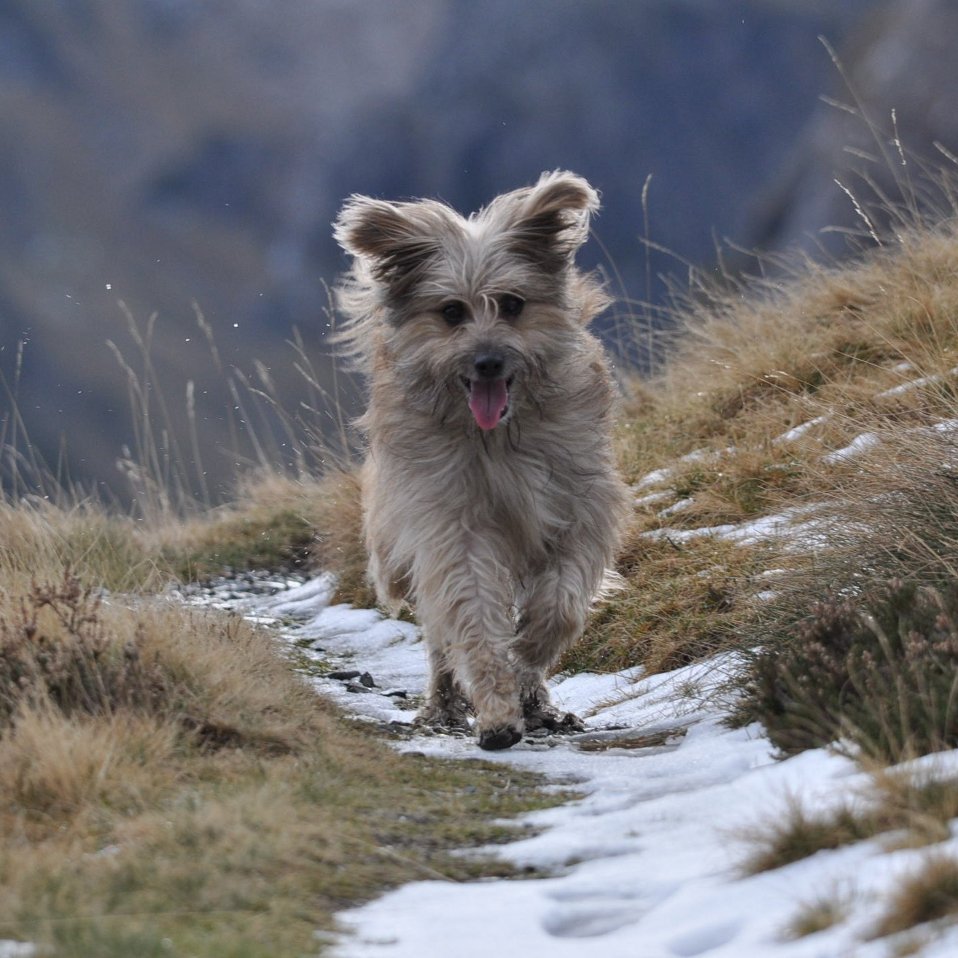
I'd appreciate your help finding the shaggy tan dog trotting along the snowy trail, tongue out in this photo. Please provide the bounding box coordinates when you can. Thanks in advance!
[334,171,628,750]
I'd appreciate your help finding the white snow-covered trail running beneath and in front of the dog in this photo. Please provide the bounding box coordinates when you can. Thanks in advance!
[199,577,958,958]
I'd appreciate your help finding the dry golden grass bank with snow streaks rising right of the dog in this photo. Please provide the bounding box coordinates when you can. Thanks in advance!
[600,224,958,684]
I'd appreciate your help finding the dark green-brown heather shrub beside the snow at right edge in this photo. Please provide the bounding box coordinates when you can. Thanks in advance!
[736,580,958,762]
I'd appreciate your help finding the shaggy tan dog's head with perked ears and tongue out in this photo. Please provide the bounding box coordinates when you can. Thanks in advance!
[335,172,606,431]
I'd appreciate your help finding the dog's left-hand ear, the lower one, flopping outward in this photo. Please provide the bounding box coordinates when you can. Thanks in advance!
[333,195,441,296]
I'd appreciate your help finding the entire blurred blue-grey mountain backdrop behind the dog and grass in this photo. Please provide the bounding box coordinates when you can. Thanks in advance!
[0,0,958,501]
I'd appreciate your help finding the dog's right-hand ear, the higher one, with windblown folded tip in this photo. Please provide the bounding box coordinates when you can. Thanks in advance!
[501,170,599,273]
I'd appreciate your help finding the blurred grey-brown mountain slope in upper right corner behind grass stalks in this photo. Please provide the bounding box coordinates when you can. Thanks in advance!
[750,0,958,256]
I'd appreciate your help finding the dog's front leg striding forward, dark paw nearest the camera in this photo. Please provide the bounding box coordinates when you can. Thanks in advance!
[415,536,523,749]
